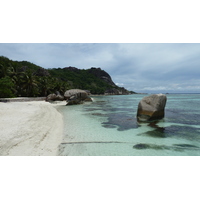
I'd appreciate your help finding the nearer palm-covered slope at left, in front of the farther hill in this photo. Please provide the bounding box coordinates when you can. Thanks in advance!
[0,56,70,98]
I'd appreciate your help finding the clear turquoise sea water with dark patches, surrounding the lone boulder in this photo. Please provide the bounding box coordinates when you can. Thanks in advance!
[59,94,200,156]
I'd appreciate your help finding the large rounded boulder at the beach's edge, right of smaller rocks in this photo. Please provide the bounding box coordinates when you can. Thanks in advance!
[64,89,92,105]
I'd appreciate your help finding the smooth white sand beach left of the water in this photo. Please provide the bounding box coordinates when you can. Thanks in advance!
[0,101,63,156]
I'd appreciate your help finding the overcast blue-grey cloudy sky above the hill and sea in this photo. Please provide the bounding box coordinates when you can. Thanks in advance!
[0,43,200,93]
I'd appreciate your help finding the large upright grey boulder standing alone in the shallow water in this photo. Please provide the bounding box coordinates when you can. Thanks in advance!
[137,94,167,122]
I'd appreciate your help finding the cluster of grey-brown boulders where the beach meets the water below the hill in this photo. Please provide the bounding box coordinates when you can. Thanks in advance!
[46,89,92,105]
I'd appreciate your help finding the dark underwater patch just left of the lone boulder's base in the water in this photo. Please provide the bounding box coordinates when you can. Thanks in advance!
[102,113,138,131]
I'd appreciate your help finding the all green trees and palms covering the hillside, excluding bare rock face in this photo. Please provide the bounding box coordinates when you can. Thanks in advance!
[0,56,133,98]
